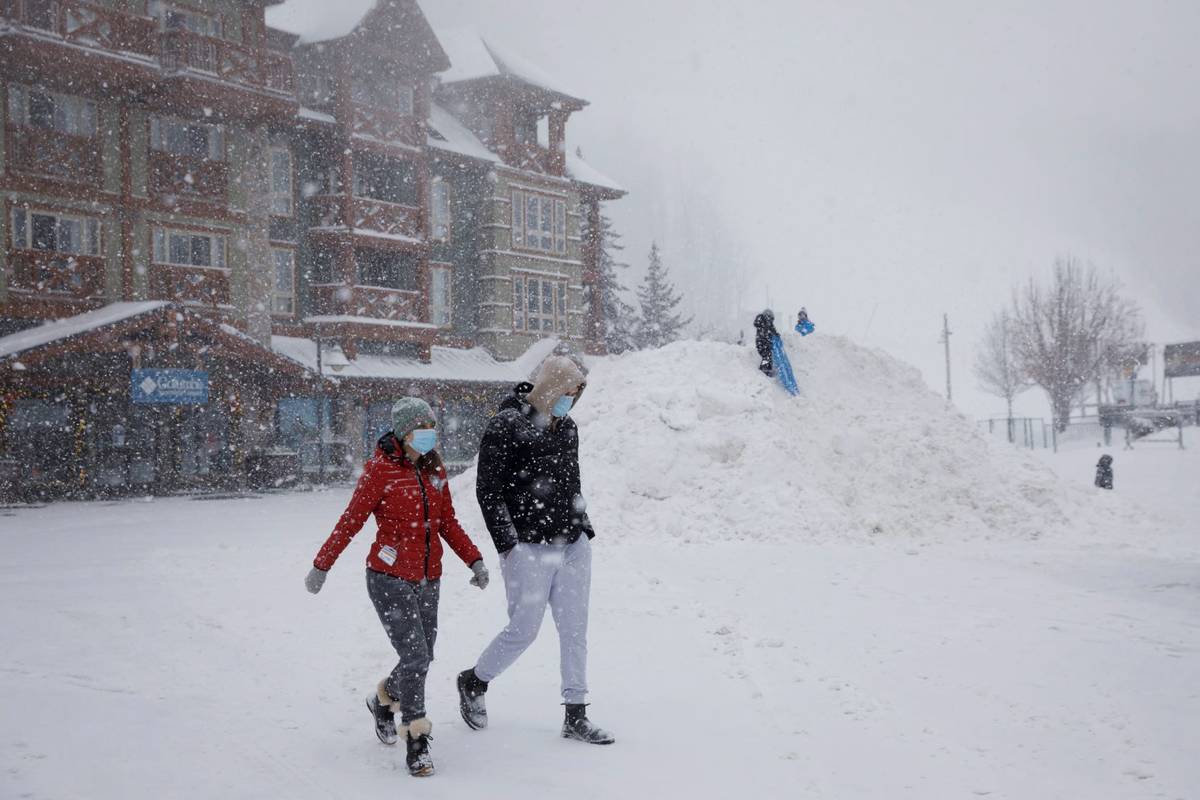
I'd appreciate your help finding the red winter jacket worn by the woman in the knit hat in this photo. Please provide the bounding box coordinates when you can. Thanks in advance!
[312,449,484,581]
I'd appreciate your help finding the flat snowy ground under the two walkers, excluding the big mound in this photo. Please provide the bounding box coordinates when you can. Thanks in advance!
[0,482,1200,800]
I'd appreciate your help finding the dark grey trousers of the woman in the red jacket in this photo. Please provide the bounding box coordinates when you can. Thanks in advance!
[367,570,440,724]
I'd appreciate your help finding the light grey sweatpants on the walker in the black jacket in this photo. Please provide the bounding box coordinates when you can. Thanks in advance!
[475,536,592,703]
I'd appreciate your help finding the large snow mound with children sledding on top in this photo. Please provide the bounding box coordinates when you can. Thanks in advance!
[456,336,1141,541]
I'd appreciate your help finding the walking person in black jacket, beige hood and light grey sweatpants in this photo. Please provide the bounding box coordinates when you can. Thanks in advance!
[457,355,614,745]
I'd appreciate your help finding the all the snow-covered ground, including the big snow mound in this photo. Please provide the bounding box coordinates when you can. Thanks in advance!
[0,337,1200,800]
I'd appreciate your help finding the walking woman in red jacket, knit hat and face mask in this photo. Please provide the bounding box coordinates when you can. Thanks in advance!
[305,397,487,777]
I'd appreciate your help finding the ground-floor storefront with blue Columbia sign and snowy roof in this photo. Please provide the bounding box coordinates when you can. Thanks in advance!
[0,302,554,501]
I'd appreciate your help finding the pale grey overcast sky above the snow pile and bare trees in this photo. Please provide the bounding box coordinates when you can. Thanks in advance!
[421,0,1200,415]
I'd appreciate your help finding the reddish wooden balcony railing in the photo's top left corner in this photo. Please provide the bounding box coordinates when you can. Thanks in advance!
[0,0,158,58]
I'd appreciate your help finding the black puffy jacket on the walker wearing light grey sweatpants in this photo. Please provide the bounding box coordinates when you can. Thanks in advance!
[475,383,595,554]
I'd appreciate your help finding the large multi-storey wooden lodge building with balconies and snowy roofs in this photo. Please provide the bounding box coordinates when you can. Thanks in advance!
[0,0,624,497]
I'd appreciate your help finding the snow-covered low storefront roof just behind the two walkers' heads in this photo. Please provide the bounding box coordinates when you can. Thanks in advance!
[271,336,558,384]
